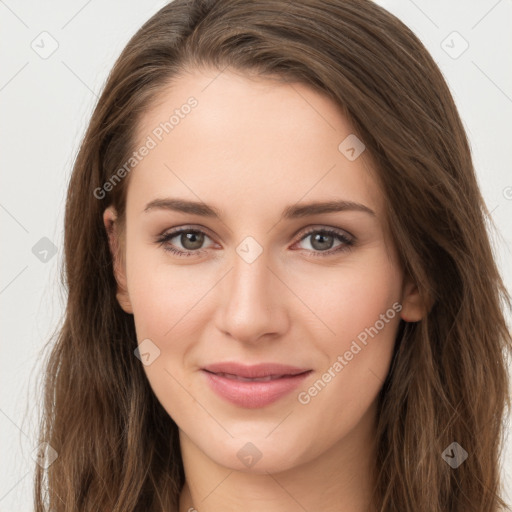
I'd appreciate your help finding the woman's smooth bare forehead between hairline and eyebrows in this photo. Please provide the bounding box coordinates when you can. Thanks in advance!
[128,66,382,220]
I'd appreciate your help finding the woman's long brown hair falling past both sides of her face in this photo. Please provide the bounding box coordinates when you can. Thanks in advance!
[35,0,512,512]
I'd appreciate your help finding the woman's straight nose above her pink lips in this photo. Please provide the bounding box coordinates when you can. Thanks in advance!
[217,247,290,344]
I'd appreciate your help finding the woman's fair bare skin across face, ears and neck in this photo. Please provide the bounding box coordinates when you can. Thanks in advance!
[104,69,424,512]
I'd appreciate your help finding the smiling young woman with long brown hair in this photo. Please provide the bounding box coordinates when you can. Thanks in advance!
[35,0,512,512]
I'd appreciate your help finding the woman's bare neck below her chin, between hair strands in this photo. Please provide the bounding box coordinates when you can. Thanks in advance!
[179,404,376,512]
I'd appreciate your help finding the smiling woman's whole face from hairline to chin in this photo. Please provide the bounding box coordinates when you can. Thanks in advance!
[104,66,419,472]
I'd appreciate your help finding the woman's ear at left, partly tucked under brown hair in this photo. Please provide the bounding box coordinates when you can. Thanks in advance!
[103,206,133,314]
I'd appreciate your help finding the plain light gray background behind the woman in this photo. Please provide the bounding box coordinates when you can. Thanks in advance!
[0,0,512,512]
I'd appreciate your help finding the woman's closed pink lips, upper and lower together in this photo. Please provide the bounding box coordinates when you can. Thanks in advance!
[201,362,312,409]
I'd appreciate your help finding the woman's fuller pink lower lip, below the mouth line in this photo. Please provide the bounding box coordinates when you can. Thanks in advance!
[202,370,311,409]
